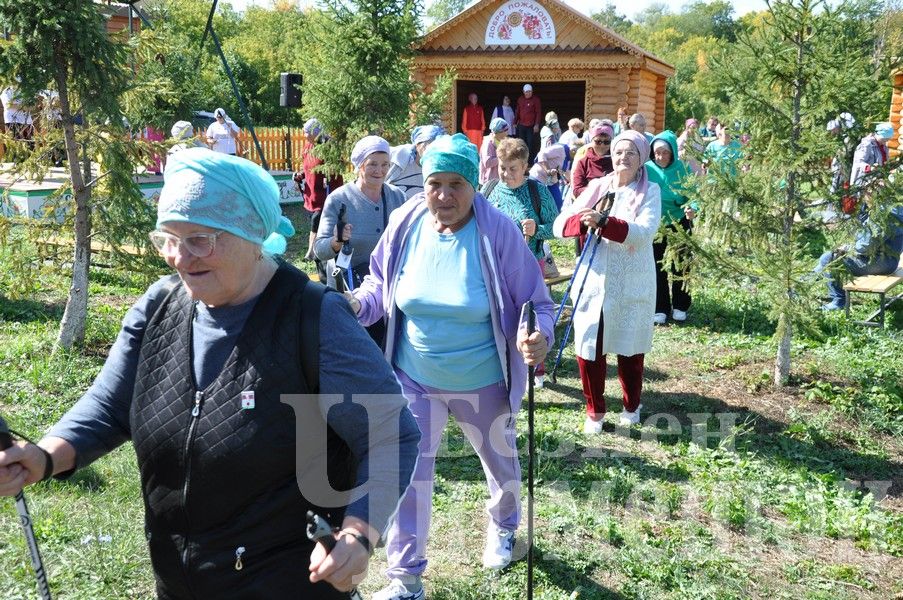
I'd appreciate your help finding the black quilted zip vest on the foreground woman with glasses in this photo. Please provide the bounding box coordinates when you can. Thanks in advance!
[130,263,348,599]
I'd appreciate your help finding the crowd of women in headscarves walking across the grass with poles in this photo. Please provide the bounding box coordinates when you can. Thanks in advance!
[0,101,896,600]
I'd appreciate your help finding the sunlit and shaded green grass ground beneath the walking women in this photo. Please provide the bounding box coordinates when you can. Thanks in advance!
[0,208,903,600]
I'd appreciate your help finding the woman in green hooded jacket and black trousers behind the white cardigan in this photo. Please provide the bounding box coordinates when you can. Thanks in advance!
[646,131,697,325]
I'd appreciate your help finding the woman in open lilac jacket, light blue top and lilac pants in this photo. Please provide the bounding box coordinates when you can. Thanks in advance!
[348,134,554,600]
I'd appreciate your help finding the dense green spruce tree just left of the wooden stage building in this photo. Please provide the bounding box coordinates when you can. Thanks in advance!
[304,0,421,173]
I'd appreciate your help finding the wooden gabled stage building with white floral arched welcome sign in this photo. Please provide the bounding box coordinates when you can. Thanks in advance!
[412,0,674,132]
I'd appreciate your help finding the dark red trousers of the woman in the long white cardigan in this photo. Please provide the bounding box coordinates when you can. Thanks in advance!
[577,316,646,420]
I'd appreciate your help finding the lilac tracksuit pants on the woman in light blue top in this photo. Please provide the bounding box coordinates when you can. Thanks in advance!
[386,368,520,578]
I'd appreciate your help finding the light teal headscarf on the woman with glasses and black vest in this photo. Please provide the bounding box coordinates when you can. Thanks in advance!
[157,148,295,254]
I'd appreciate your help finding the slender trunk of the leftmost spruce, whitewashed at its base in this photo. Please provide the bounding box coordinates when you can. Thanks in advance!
[53,57,91,352]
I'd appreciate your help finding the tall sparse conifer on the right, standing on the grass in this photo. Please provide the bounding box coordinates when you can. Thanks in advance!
[684,0,892,386]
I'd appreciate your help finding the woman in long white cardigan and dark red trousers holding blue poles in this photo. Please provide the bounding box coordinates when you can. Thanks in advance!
[554,130,661,434]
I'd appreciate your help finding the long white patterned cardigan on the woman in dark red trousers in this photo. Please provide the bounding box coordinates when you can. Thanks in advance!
[553,176,662,360]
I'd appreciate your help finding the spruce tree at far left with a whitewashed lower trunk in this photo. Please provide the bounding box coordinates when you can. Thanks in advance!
[0,0,160,348]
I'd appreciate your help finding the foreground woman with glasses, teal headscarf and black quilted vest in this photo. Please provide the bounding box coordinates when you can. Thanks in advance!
[0,149,419,599]
